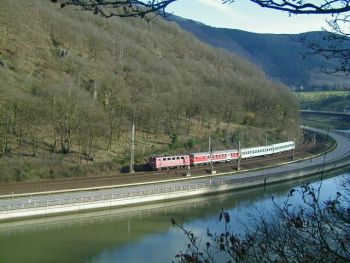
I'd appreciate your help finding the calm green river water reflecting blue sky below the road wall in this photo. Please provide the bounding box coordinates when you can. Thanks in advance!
[0,169,350,263]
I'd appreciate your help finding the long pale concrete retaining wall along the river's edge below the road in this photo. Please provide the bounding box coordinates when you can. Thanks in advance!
[0,160,350,220]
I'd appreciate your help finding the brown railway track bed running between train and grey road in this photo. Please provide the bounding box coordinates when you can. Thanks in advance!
[0,146,318,195]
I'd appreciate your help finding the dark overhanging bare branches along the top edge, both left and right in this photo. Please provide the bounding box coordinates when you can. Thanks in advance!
[50,0,350,74]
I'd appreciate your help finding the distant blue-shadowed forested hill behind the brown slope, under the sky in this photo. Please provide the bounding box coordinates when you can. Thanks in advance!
[167,16,350,90]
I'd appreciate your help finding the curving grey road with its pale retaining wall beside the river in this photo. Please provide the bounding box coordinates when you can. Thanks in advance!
[0,129,350,221]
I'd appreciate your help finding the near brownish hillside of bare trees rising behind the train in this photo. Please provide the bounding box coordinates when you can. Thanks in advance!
[0,0,299,181]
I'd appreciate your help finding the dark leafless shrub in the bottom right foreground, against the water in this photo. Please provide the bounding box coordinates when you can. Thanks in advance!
[172,174,350,262]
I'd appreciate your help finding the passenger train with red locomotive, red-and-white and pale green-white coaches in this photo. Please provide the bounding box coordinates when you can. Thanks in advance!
[148,141,295,170]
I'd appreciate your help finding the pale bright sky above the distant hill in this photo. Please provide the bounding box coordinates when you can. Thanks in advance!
[167,0,327,34]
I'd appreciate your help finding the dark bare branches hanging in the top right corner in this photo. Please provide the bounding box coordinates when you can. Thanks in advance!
[222,0,350,74]
